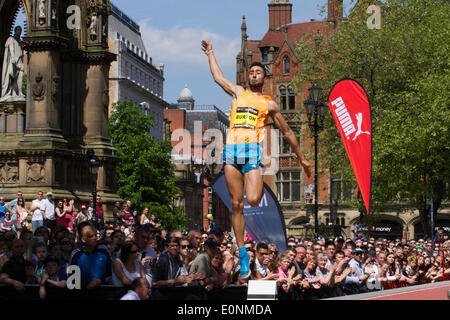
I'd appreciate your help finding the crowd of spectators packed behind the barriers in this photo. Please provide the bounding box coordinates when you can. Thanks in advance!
[0,192,450,300]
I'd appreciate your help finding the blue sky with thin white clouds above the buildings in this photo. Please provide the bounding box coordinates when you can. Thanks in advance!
[14,0,354,110]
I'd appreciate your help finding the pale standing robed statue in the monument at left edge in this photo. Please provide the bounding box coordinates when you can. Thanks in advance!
[0,26,25,102]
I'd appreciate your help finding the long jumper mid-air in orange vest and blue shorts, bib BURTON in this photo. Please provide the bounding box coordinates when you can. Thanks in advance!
[202,40,311,278]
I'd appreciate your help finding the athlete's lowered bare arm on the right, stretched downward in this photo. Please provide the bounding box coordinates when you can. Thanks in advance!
[269,100,311,177]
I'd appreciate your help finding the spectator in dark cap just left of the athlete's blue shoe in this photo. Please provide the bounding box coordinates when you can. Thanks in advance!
[189,238,219,290]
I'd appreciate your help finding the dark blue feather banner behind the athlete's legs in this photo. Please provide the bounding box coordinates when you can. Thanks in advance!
[213,175,287,252]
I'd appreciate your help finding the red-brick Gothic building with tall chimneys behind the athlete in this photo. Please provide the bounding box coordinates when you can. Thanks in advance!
[236,0,450,238]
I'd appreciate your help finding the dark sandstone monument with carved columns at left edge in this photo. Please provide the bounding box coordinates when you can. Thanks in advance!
[0,0,119,218]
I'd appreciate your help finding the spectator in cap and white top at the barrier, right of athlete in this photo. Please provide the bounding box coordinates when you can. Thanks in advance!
[344,248,369,294]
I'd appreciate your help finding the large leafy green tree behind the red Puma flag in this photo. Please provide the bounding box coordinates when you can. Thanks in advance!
[296,0,450,238]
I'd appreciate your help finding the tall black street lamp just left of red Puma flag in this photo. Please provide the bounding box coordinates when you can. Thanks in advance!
[304,81,326,237]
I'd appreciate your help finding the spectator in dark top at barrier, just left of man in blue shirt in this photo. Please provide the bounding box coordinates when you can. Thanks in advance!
[39,256,67,300]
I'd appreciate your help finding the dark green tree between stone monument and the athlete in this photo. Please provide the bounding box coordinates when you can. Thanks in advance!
[109,101,188,230]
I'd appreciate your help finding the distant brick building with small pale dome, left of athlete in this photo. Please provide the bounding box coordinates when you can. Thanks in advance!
[164,86,231,230]
